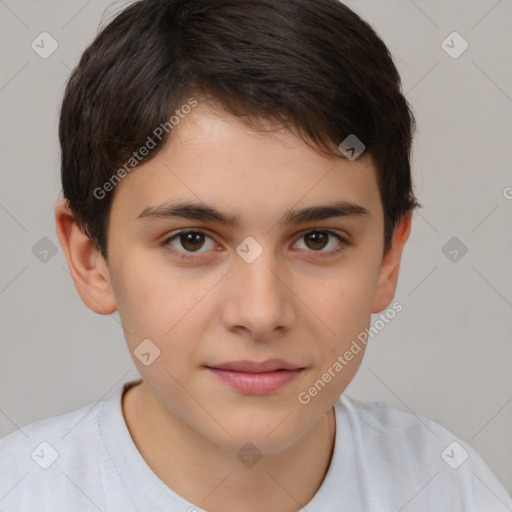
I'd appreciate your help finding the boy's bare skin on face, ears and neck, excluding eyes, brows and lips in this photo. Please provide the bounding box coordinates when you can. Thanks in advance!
[55,103,412,512]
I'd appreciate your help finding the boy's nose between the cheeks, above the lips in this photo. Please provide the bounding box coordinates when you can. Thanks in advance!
[222,250,296,341]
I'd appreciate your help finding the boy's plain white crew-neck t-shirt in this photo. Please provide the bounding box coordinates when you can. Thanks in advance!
[0,380,512,512]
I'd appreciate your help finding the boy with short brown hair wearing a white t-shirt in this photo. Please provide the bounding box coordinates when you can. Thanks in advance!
[0,0,512,512]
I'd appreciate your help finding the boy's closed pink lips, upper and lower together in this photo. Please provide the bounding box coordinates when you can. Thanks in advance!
[206,359,304,395]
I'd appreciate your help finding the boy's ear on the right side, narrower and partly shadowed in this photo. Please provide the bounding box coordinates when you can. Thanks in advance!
[372,210,412,313]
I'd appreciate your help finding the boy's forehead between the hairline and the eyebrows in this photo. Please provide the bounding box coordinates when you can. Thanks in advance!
[111,103,382,228]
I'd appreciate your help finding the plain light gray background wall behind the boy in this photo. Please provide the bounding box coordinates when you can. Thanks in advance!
[0,0,512,492]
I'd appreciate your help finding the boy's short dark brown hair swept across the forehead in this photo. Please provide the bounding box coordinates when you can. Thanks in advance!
[59,0,421,260]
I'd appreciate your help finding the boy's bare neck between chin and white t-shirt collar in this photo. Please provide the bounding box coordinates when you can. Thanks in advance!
[123,382,336,512]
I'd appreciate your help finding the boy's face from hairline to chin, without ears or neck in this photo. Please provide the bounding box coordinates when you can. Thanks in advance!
[80,104,406,453]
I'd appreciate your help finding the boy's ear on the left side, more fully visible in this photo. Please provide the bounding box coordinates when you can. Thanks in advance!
[55,199,117,315]
